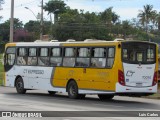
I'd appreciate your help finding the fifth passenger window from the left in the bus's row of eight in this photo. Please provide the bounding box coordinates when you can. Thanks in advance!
[63,48,76,67]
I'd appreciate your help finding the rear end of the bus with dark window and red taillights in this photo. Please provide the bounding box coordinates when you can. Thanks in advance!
[116,42,158,96]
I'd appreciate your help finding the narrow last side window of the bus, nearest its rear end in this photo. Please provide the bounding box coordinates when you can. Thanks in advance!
[107,48,115,68]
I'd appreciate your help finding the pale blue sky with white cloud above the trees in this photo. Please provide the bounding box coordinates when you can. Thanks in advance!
[0,0,160,24]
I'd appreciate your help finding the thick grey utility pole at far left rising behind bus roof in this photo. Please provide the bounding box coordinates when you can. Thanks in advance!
[10,0,14,42]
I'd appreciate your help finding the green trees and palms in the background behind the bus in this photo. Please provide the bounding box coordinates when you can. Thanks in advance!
[0,0,160,42]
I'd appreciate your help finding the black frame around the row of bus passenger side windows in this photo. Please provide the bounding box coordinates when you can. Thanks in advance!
[12,45,116,69]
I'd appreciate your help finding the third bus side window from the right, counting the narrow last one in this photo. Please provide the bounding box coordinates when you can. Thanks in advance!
[76,48,90,67]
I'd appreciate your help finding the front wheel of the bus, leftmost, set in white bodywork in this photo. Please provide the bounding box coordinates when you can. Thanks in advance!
[15,77,26,94]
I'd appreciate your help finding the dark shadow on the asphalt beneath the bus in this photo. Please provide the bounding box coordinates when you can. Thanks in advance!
[4,92,156,105]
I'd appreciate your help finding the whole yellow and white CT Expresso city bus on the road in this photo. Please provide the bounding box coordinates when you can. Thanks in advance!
[4,40,158,100]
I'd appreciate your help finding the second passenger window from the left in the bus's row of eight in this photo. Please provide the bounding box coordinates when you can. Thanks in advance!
[28,48,37,65]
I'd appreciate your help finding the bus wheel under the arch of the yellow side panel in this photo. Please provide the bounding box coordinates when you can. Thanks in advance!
[68,81,79,99]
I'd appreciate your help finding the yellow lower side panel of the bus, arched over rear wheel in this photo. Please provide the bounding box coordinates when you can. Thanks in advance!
[52,67,117,91]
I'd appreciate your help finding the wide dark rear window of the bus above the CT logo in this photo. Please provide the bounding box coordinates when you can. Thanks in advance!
[122,42,156,64]
